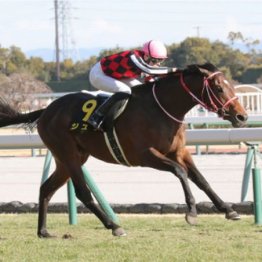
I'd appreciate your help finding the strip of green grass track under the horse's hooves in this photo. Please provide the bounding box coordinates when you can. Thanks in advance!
[0,214,262,262]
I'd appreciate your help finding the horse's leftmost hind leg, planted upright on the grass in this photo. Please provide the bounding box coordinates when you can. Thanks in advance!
[37,169,69,238]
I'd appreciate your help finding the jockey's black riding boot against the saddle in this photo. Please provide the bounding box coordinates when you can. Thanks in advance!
[87,92,130,131]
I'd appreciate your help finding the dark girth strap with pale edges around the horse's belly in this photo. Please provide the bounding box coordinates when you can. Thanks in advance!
[104,127,131,166]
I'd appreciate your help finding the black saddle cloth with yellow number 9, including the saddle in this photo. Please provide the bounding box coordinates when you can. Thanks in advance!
[70,91,130,131]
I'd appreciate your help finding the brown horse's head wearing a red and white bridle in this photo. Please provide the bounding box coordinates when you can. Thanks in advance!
[184,64,248,127]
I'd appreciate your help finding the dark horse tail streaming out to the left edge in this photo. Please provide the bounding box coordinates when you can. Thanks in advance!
[0,99,45,127]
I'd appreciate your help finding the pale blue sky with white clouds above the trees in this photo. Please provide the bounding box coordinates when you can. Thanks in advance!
[0,0,262,58]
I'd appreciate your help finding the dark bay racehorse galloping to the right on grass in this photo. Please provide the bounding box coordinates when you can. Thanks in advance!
[0,63,247,238]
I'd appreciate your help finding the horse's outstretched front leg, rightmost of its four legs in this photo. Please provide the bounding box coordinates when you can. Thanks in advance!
[184,151,240,220]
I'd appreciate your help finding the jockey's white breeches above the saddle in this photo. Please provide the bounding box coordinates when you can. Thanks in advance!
[89,62,142,94]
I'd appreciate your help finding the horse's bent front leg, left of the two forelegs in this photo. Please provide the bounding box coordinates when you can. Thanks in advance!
[144,148,197,225]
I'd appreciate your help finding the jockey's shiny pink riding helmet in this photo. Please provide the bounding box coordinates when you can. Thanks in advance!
[142,40,167,59]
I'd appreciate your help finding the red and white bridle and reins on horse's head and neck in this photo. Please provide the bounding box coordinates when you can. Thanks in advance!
[152,71,238,124]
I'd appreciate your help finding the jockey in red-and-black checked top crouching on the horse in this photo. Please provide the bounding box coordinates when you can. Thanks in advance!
[88,40,176,130]
